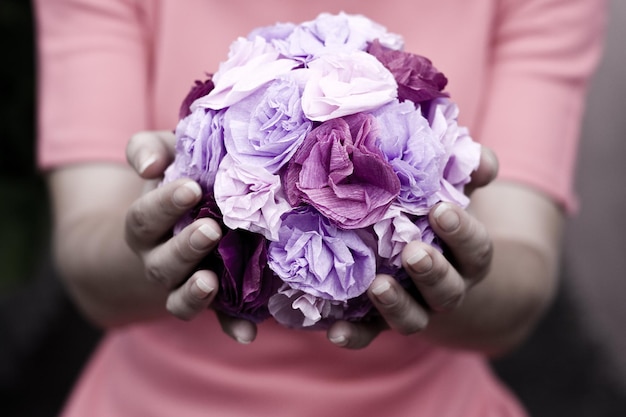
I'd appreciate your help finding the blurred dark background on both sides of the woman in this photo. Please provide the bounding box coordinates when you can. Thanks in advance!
[0,0,626,417]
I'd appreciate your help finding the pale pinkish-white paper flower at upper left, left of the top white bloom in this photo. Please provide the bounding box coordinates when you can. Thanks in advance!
[191,37,299,111]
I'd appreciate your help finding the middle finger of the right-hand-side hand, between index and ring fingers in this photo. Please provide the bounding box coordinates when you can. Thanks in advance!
[402,242,468,312]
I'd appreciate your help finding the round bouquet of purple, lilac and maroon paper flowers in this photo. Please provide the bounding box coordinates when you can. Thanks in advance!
[164,13,480,328]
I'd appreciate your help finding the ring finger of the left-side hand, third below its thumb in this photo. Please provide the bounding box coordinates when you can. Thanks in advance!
[166,270,218,320]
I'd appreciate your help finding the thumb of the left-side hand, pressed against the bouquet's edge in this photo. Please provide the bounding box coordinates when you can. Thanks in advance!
[126,131,176,178]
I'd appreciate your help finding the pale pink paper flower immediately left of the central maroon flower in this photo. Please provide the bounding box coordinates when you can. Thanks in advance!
[213,155,291,240]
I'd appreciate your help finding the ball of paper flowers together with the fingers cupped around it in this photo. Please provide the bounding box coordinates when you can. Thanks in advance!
[127,14,497,347]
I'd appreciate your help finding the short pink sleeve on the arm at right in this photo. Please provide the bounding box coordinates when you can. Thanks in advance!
[477,0,605,211]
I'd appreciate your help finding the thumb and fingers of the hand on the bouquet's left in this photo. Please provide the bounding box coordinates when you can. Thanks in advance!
[125,132,256,343]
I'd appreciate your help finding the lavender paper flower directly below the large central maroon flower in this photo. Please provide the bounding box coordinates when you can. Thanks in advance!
[268,209,376,301]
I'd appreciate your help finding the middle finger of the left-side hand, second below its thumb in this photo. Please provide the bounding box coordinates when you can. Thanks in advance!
[142,218,220,289]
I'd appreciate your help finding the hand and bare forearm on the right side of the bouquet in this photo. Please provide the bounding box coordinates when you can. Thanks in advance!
[328,145,561,354]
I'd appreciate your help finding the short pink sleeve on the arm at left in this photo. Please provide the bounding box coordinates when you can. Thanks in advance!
[36,0,148,169]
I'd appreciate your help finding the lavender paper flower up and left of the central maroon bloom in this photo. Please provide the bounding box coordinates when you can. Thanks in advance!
[224,78,313,174]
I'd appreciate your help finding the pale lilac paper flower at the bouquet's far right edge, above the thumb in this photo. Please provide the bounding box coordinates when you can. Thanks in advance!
[428,98,481,207]
